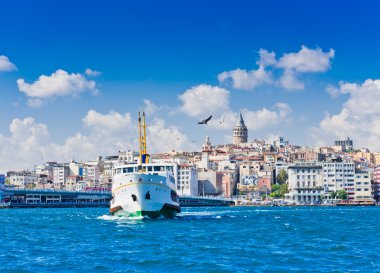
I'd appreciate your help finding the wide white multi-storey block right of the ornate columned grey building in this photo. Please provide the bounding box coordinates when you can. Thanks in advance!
[322,159,355,201]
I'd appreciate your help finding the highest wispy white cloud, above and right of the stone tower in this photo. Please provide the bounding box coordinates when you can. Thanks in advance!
[218,46,335,90]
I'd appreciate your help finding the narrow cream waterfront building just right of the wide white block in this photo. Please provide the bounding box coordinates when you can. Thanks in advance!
[354,170,374,202]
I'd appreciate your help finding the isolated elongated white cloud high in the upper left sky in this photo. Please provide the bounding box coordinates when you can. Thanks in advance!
[17,69,98,106]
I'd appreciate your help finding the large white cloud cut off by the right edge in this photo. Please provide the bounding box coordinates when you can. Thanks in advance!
[311,79,380,150]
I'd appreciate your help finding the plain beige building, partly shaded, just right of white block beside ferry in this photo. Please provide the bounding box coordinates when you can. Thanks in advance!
[198,169,223,196]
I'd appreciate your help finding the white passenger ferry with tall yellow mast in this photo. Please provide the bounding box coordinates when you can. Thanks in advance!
[110,112,181,218]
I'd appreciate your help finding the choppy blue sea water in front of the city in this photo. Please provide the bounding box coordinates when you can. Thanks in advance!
[0,207,380,272]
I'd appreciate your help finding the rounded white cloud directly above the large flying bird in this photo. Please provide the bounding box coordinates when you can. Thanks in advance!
[179,84,230,117]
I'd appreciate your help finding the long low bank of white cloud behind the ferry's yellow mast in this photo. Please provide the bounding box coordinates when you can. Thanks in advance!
[0,110,194,170]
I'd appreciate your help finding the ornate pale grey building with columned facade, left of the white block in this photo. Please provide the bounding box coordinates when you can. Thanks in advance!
[285,163,324,204]
